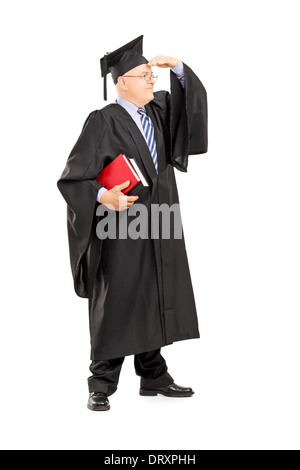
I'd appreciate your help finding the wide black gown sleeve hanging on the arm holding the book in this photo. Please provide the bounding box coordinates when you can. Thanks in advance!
[57,111,109,298]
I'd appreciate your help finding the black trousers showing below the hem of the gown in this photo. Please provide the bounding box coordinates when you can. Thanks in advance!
[88,349,174,396]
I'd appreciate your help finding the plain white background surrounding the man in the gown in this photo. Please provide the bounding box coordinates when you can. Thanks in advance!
[0,0,300,450]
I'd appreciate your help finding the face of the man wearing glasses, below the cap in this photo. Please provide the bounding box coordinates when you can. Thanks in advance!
[119,64,155,106]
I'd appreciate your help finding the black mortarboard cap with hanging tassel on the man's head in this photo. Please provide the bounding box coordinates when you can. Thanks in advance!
[100,35,149,101]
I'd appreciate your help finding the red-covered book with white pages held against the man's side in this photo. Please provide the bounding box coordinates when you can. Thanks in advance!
[97,153,148,194]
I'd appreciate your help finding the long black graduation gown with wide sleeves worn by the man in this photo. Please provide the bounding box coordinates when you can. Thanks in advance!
[57,63,207,360]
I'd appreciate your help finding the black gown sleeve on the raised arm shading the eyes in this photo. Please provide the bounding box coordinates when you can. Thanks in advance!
[154,62,208,172]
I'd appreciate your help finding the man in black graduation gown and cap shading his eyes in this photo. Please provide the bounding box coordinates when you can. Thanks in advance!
[57,36,207,410]
